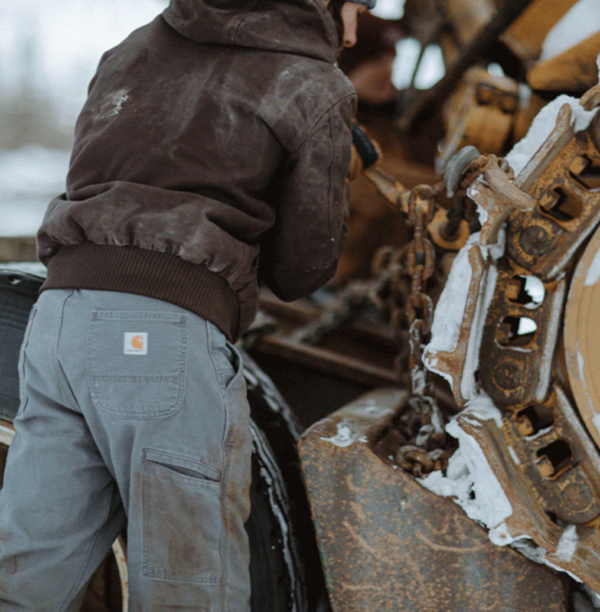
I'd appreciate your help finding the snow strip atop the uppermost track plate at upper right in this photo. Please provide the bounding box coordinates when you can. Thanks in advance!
[506,95,600,174]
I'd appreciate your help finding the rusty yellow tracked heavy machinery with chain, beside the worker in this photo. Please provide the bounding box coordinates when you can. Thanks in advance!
[0,0,600,612]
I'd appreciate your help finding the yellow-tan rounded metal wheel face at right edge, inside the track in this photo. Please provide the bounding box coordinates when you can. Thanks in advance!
[564,224,600,447]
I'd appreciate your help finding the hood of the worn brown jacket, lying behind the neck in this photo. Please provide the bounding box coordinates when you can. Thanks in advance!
[163,0,339,63]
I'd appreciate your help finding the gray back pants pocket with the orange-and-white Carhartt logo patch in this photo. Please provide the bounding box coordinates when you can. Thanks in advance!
[87,310,187,419]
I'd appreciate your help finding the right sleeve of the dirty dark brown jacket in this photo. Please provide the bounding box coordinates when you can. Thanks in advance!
[259,95,355,301]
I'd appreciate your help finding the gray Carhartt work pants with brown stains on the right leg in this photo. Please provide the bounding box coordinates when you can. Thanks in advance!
[0,289,252,612]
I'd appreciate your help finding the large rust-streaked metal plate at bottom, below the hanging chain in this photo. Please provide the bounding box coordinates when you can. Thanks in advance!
[300,390,567,612]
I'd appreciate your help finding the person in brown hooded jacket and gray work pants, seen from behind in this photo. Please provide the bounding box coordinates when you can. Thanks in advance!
[0,0,374,612]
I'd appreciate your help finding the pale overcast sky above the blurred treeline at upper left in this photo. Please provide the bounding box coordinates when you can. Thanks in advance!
[0,0,404,122]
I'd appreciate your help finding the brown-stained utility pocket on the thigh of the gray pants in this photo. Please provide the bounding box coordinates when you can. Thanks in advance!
[142,449,222,585]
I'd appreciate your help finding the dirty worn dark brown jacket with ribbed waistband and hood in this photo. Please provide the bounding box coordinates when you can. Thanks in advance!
[38,0,355,340]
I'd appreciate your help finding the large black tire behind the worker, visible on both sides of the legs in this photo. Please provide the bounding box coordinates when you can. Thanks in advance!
[0,266,331,612]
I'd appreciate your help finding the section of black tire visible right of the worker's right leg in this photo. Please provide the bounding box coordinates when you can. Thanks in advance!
[244,353,331,612]
